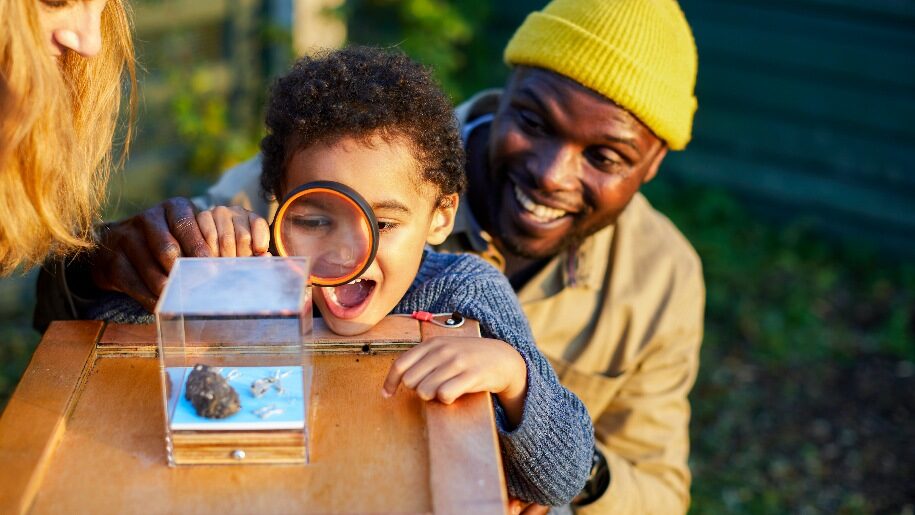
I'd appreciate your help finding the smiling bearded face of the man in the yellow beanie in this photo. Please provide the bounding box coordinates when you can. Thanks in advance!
[487,67,666,258]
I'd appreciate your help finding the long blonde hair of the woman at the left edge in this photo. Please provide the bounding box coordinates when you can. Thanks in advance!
[0,0,136,275]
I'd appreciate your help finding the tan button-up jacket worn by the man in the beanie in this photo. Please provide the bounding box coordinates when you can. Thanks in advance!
[159,91,705,514]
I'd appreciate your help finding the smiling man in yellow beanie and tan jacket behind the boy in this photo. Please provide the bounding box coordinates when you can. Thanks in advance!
[36,0,705,513]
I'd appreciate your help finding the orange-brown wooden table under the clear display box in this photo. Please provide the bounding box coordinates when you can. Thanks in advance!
[0,317,507,513]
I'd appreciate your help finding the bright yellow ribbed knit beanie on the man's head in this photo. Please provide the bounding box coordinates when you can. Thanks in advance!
[504,0,697,150]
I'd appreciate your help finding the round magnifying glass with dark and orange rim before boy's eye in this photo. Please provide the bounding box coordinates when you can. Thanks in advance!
[271,181,378,286]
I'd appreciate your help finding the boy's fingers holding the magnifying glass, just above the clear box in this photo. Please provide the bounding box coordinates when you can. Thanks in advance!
[197,206,270,257]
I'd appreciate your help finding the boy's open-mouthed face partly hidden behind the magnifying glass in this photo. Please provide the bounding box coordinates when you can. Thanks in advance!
[283,136,457,335]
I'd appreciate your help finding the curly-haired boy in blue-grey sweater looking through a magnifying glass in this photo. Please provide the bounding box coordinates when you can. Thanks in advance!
[91,48,593,506]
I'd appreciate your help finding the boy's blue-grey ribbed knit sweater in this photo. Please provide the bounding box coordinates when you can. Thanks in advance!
[88,252,594,506]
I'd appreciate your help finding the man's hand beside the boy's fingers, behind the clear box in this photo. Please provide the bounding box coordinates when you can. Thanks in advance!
[89,197,212,311]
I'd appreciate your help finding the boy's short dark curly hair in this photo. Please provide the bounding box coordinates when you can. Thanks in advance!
[261,47,466,204]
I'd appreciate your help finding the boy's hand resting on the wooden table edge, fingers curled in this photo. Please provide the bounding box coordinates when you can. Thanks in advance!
[381,336,527,426]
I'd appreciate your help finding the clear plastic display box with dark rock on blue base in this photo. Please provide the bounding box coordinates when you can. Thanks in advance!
[156,257,314,466]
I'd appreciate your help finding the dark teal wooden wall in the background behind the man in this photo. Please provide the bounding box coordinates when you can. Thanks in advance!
[664,0,915,253]
